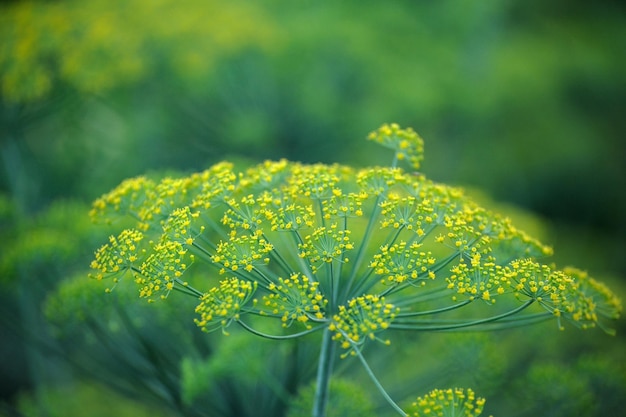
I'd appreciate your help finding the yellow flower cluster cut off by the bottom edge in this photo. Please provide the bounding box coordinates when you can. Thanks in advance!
[407,388,485,417]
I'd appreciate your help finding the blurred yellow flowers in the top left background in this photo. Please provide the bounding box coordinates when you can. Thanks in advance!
[0,0,276,104]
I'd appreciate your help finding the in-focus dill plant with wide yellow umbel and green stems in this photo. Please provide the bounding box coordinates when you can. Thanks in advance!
[91,124,621,417]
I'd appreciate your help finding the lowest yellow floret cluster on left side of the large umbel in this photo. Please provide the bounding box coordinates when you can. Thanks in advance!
[195,278,257,334]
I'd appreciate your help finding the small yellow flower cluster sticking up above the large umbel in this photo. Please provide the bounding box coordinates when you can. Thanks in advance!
[367,123,424,169]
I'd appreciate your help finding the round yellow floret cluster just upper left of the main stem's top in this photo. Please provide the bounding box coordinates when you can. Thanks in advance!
[263,273,328,329]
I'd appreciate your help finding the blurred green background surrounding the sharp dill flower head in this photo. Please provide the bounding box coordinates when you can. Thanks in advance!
[0,0,626,416]
